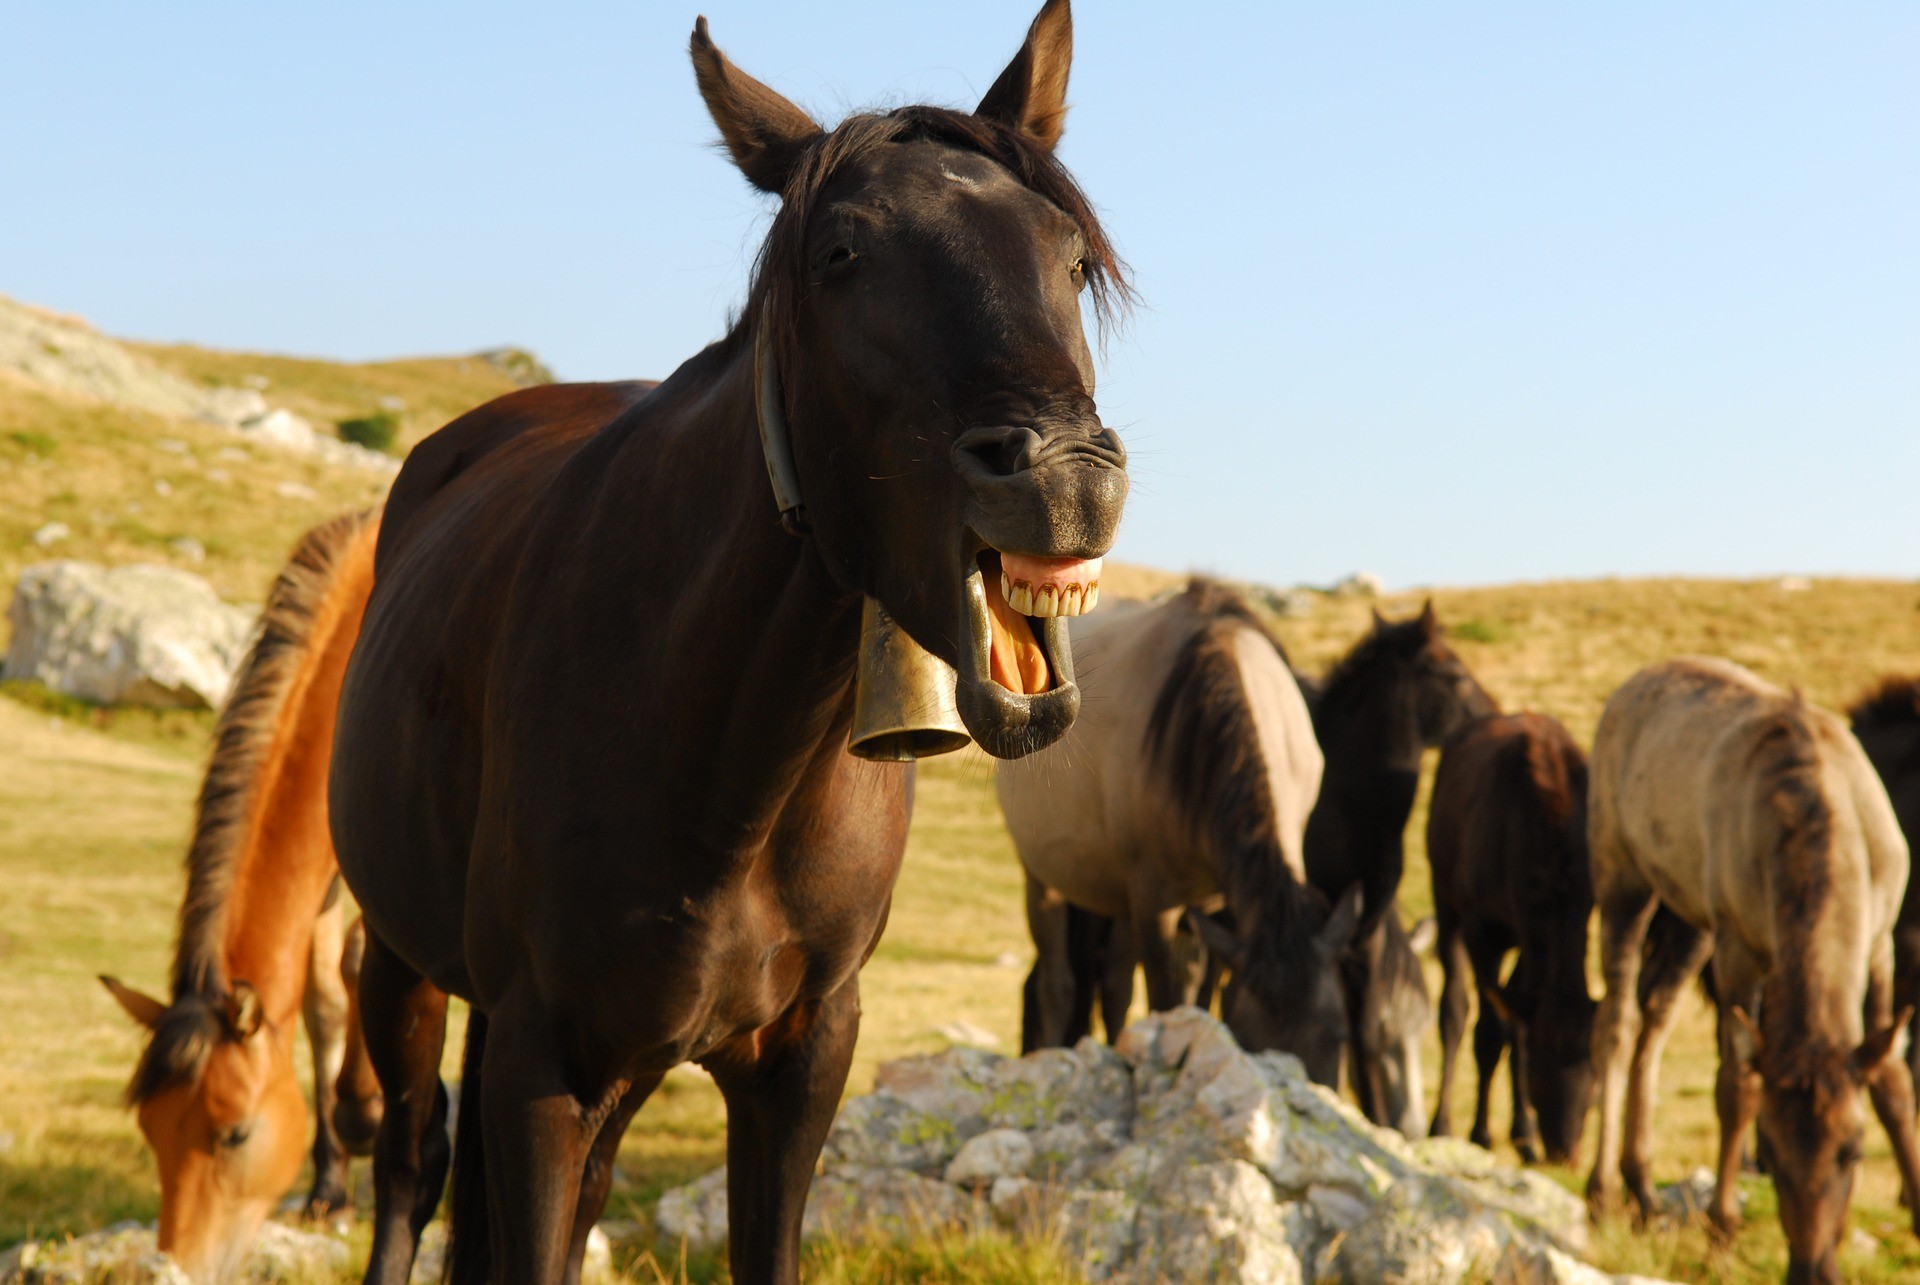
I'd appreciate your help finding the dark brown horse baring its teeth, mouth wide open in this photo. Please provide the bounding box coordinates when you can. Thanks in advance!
[330,0,1127,1285]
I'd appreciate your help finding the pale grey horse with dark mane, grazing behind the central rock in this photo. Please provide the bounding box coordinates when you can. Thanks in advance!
[998,578,1359,1085]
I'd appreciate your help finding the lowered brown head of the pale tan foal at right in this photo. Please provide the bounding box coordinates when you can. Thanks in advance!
[1732,1006,1912,1283]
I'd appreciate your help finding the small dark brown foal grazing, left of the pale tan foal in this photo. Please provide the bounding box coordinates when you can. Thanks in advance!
[1427,715,1594,1164]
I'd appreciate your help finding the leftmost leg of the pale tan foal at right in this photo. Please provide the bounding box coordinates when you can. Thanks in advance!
[1586,875,1659,1214]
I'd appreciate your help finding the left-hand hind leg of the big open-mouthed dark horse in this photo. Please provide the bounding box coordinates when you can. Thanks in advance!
[359,930,449,1285]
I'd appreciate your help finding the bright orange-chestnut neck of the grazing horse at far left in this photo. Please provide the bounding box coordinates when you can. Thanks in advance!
[223,549,371,1026]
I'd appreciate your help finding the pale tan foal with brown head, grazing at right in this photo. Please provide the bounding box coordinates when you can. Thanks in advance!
[1588,659,1920,1281]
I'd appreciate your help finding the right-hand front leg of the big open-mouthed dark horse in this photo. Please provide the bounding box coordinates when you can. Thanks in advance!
[703,976,860,1285]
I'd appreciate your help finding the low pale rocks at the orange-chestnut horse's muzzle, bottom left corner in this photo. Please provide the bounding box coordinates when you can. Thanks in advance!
[0,1222,349,1285]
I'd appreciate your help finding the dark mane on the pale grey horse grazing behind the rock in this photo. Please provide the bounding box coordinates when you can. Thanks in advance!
[1144,576,1304,937]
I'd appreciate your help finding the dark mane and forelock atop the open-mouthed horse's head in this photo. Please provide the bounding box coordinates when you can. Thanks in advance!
[728,106,1133,378]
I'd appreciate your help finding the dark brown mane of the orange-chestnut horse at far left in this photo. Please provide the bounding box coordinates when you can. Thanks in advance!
[127,509,380,1103]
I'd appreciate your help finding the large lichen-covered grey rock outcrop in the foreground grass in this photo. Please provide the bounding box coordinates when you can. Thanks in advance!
[657,1008,1674,1285]
